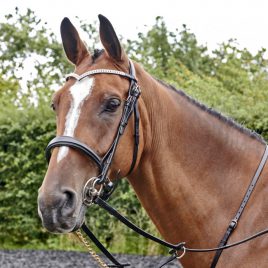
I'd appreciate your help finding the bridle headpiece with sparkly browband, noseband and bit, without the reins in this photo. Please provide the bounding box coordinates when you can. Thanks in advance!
[45,61,141,206]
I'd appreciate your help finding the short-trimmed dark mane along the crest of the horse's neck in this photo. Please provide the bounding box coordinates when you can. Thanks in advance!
[156,79,266,143]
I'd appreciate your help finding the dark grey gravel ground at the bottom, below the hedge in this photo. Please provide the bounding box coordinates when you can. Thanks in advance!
[0,250,182,268]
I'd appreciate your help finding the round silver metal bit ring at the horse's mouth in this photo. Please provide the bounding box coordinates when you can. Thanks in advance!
[83,177,103,206]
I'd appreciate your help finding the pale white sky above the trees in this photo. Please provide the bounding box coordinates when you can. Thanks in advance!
[0,0,268,53]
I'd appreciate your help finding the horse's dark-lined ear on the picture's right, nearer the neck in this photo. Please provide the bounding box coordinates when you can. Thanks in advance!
[98,14,126,61]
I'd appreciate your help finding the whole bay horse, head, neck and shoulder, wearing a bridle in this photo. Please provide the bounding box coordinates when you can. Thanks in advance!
[38,15,268,267]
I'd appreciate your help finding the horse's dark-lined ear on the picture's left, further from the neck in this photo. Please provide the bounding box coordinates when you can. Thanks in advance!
[60,18,89,65]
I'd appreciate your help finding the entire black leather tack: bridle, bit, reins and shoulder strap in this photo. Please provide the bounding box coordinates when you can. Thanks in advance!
[45,61,268,268]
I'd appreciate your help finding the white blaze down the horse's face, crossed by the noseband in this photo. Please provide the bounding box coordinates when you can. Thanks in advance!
[57,77,94,163]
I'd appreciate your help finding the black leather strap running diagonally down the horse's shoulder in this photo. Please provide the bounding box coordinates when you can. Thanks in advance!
[210,145,268,268]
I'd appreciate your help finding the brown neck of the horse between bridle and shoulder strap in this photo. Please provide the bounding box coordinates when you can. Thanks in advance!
[129,66,264,264]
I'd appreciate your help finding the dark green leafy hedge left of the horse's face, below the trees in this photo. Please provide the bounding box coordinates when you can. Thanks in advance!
[0,104,55,245]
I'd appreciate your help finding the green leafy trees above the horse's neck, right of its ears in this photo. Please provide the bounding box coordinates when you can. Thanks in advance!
[127,17,268,139]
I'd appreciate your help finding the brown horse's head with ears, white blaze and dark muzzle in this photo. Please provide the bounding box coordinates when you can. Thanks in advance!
[38,15,142,233]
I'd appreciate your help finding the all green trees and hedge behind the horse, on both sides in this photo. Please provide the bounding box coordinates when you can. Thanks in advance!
[0,9,268,254]
